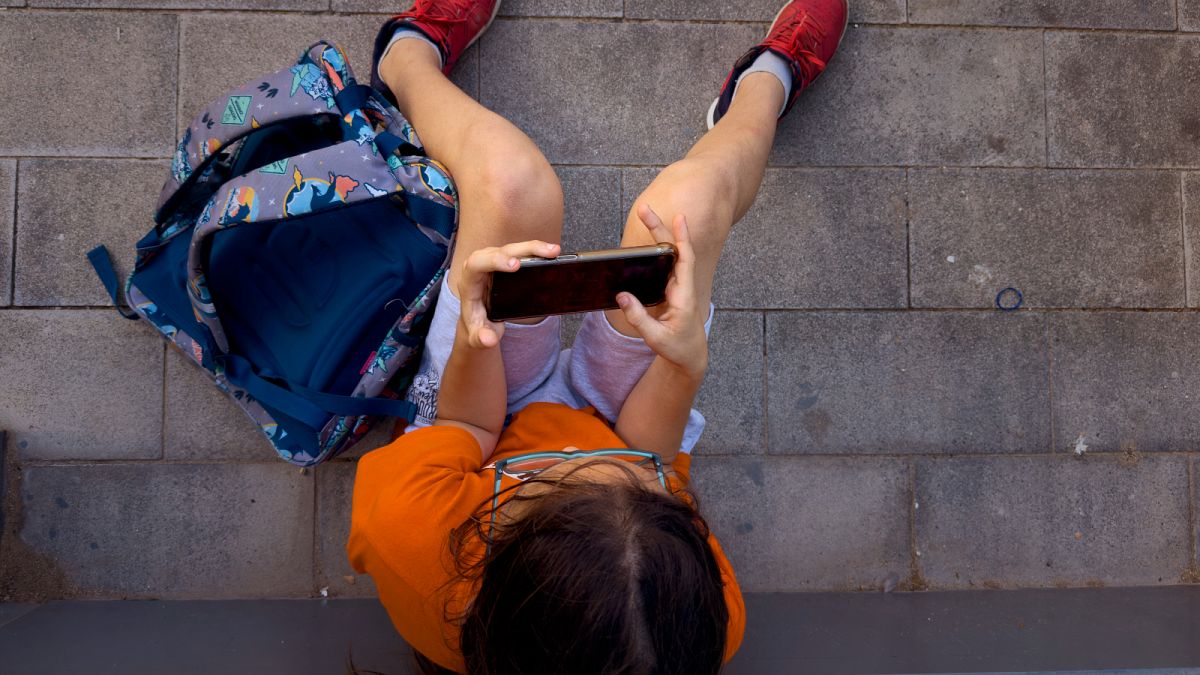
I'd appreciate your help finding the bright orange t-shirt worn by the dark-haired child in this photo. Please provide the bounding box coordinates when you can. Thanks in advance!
[347,402,745,671]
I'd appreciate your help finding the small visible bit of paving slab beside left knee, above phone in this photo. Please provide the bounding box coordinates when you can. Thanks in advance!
[554,167,625,251]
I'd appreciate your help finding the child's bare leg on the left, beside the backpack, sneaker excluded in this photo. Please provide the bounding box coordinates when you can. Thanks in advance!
[379,40,563,302]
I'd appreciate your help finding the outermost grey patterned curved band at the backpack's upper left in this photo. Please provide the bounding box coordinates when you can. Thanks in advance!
[155,41,354,225]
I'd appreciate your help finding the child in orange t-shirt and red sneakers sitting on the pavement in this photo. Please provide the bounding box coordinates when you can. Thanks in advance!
[348,0,846,675]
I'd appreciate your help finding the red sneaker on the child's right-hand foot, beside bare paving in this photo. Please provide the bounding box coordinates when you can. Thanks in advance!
[708,0,850,129]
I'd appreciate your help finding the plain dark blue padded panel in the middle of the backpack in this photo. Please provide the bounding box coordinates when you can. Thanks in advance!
[208,197,445,395]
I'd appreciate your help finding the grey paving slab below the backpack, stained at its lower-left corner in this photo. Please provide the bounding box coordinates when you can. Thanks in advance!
[22,462,313,598]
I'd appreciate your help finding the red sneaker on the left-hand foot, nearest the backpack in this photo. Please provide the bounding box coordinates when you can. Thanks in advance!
[372,0,500,94]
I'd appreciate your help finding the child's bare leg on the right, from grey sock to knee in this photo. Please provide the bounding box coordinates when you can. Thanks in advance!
[607,73,785,336]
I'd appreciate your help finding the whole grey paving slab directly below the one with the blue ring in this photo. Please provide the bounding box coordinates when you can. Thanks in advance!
[767,312,1050,454]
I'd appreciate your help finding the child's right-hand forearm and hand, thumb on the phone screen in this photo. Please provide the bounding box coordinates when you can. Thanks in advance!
[616,208,708,464]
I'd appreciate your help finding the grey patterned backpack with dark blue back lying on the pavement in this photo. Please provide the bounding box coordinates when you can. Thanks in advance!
[88,41,458,466]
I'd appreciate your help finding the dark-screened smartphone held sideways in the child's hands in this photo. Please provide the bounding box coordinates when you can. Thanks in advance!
[484,244,678,322]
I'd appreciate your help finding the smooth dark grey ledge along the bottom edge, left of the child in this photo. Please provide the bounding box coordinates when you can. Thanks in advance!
[0,599,418,675]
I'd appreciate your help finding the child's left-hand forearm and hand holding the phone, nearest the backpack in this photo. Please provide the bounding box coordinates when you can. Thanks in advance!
[433,241,558,460]
